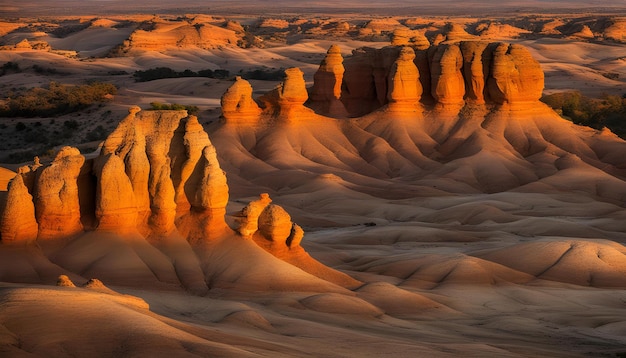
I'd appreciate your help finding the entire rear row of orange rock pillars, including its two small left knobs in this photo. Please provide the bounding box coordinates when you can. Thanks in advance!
[222,40,544,119]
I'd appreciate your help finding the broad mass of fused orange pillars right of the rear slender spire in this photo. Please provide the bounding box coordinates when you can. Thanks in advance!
[340,40,544,117]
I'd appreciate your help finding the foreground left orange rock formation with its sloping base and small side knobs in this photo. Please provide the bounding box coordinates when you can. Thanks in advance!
[0,105,358,294]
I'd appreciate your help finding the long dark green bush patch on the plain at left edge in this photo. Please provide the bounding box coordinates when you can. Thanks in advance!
[0,82,117,117]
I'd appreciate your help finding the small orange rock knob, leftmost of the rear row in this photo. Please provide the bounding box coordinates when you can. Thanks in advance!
[220,76,261,123]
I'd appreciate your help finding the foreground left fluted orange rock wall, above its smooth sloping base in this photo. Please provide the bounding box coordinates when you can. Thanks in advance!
[2,107,228,242]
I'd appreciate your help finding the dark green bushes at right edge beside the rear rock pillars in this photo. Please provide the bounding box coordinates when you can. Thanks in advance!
[541,91,626,138]
